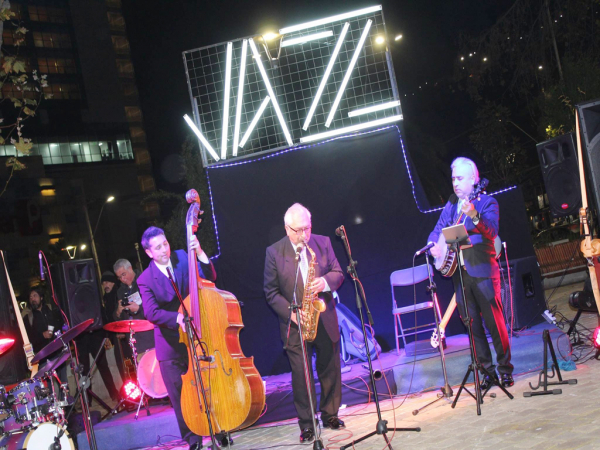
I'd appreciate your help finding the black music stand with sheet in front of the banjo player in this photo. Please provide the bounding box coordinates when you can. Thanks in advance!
[442,229,514,416]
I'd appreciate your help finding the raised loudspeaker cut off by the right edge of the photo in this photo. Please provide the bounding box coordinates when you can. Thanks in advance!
[576,99,600,218]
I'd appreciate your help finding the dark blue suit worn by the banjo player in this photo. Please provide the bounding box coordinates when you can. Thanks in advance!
[428,194,513,374]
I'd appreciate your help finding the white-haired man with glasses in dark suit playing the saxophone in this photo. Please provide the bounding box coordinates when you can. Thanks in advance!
[264,203,345,443]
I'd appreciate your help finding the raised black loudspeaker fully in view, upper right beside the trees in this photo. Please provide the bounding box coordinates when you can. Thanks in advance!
[536,133,581,217]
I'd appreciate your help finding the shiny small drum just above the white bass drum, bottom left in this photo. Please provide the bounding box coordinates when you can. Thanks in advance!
[4,378,50,432]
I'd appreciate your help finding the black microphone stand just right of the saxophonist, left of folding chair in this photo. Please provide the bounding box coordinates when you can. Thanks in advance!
[336,229,421,450]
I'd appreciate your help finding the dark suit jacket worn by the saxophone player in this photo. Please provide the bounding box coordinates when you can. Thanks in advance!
[264,234,344,342]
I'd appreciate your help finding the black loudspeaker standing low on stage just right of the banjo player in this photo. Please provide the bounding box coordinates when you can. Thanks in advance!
[500,256,546,331]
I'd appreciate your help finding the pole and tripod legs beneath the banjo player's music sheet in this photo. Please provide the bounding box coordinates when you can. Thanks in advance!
[450,237,514,416]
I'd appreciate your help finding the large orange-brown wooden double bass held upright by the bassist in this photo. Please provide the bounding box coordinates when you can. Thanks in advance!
[180,189,265,436]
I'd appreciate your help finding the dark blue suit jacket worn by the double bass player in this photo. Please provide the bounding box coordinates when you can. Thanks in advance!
[137,250,217,361]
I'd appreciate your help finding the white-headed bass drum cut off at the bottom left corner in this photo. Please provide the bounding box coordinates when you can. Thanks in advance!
[0,422,75,450]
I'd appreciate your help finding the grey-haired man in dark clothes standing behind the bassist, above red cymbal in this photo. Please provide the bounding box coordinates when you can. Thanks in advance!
[113,259,154,356]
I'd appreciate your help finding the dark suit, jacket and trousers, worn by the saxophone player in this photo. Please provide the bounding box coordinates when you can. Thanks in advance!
[264,234,344,429]
